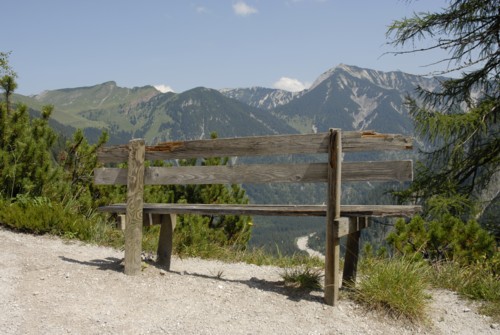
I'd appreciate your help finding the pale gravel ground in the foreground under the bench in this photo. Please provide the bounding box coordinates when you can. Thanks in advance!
[0,228,500,334]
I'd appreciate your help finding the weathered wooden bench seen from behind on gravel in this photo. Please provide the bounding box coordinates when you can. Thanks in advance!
[95,129,420,305]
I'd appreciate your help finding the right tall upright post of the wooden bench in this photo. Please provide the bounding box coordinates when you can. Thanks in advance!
[325,129,342,306]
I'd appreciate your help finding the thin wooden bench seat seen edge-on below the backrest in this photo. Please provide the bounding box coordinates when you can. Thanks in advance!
[99,203,421,217]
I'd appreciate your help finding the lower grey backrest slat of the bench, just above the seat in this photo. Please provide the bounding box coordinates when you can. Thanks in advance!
[94,160,413,185]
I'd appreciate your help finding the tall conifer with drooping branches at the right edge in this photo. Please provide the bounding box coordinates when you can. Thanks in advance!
[388,0,500,230]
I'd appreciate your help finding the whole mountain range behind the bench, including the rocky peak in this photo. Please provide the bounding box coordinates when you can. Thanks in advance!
[15,64,439,144]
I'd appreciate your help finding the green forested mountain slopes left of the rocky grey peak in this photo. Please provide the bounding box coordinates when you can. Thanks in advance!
[16,82,297,144]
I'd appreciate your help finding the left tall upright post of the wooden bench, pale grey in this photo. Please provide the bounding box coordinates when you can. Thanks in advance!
[125,139,146,275]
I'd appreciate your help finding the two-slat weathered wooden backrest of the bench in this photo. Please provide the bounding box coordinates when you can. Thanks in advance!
[95,131,413,185]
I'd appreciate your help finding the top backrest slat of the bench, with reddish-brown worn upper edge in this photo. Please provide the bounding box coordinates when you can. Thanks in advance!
[97,131,412,163]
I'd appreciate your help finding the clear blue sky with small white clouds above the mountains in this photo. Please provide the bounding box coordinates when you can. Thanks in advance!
[0,0,446,94]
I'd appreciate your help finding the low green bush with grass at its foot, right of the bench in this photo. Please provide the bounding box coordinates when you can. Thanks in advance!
[387,196,500,320]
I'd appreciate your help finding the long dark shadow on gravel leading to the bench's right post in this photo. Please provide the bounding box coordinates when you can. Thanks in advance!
[184,272,324,304]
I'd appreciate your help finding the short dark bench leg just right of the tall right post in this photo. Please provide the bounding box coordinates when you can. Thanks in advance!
[342,217,368,285]
